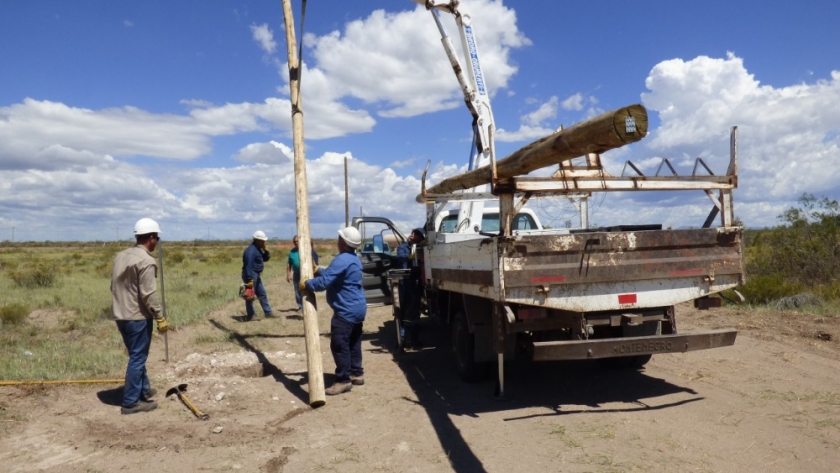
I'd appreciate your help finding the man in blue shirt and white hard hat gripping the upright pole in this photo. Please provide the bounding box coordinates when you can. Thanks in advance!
[300,227,367,396]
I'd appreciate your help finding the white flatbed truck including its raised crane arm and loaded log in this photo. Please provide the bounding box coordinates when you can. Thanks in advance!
[353,0,745,397]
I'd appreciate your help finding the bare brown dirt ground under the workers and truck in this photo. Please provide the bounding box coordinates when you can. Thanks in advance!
[0,280,840,473]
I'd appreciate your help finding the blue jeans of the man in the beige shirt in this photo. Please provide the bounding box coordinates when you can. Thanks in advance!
[117,319,154,407]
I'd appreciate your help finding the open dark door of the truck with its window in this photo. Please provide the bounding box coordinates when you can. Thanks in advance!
[353,217,407,306]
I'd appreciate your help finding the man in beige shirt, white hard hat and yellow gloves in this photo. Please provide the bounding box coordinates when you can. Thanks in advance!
[111,218,168,414]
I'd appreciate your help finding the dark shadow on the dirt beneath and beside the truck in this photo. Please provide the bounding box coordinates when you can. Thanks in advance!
[366,318,703,473]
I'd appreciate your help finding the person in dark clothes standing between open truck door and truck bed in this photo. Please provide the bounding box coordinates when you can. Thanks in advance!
[397,228,426,348]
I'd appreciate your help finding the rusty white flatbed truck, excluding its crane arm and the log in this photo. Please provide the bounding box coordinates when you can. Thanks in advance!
[352,127,745,392]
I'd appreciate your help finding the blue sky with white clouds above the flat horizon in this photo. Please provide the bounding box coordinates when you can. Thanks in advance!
[0,0,840,241]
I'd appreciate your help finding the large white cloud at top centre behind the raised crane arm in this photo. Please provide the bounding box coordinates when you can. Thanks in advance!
[296,0,530,117]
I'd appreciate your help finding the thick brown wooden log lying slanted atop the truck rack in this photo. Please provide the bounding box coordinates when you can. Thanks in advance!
[417,104,648,198]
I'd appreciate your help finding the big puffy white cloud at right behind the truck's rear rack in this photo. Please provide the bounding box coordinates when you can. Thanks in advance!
[588,53,840,226]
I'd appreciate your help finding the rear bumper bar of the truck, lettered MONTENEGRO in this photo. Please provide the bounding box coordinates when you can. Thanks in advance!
[533,329,738,361]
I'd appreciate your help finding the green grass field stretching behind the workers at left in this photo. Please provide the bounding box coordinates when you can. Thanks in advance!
[0,242,332,380]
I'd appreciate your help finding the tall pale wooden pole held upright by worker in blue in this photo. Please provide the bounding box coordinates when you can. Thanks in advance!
[283,0,326,407]
